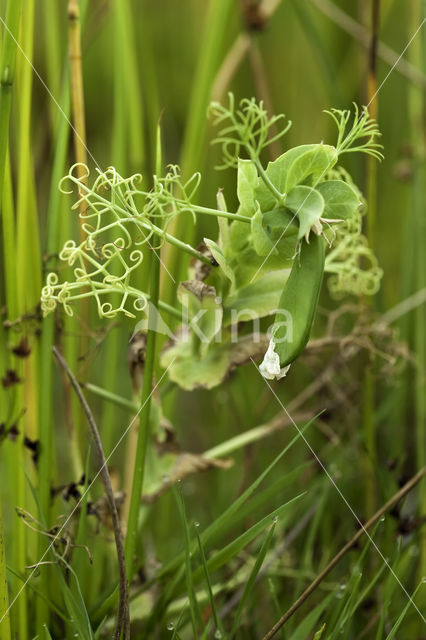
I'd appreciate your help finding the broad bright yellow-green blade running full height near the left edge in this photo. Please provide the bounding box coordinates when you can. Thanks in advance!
[7,0,41,638]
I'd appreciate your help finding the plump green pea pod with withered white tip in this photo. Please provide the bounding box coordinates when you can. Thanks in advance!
[260,235,325,379]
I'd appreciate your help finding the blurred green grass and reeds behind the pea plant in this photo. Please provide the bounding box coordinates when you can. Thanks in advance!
[0,0,426,640]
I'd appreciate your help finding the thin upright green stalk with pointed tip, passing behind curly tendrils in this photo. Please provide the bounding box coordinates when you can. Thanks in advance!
[125,127,161,581]
